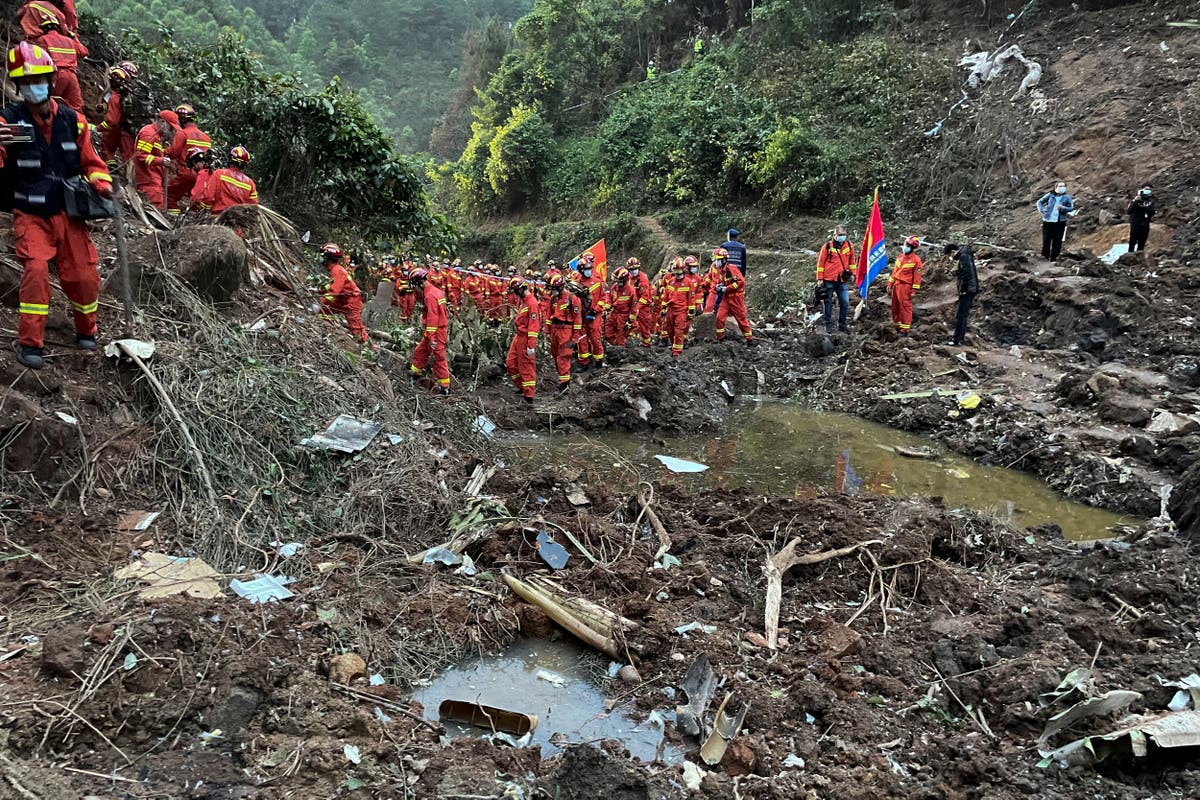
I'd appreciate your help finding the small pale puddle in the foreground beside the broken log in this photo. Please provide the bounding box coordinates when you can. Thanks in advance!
[413,639,683,763]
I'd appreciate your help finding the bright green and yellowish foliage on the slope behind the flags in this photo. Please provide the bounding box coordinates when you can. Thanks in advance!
[431,0,959,216]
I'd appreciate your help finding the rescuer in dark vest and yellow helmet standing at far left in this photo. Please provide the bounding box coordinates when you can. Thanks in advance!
[0,42,113,369]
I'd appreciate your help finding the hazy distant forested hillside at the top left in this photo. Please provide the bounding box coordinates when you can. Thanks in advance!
[79,0,530,152]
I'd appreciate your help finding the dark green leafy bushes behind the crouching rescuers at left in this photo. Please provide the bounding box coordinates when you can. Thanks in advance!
[83,18,456,252]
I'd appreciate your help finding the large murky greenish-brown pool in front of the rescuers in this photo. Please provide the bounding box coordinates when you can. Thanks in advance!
[512,402,1140,540]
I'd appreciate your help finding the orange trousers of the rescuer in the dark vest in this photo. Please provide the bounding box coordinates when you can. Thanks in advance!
[12,211,100,348]
